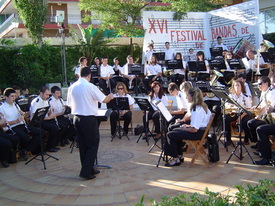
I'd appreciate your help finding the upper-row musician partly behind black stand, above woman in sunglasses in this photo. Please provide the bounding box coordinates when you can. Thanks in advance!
[121,55,140,89]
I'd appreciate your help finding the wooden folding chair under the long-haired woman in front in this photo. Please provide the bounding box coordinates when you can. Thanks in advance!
[183,113,215,167]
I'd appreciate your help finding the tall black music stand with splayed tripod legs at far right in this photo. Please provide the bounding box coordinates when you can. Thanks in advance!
[212,90,255,164]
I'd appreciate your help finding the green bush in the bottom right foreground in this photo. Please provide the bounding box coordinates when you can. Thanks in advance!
[135,179,275,206]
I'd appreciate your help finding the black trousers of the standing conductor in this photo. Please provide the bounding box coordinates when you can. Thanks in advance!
[74,115,99,176]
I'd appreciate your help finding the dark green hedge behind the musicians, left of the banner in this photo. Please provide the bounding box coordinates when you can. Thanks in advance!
[0,45,142,92]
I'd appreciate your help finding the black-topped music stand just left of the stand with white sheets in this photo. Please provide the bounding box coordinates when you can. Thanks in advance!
[135,98,155,145]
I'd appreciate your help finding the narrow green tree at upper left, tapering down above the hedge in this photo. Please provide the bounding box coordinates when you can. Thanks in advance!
[14,0,48,47]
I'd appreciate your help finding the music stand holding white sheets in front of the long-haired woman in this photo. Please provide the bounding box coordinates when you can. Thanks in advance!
[154,100,173,167]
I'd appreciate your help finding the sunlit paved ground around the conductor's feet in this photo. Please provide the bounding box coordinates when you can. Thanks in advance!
[0,111,275,206]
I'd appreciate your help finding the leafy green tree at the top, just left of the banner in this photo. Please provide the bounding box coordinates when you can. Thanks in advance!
[79,0,151,53]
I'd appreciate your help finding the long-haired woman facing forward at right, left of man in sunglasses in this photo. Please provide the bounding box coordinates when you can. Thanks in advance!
[225,80,251,146]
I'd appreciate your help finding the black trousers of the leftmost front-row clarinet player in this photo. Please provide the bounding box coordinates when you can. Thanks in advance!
[12,124,41,152]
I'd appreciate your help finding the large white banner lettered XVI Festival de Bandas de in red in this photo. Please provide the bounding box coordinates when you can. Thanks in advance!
[143,0,262,58]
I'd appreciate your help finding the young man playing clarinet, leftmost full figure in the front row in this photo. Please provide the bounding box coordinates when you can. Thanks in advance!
[0,88,40,160]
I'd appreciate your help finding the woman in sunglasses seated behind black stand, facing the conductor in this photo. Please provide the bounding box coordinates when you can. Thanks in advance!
[110,82,135,138]
